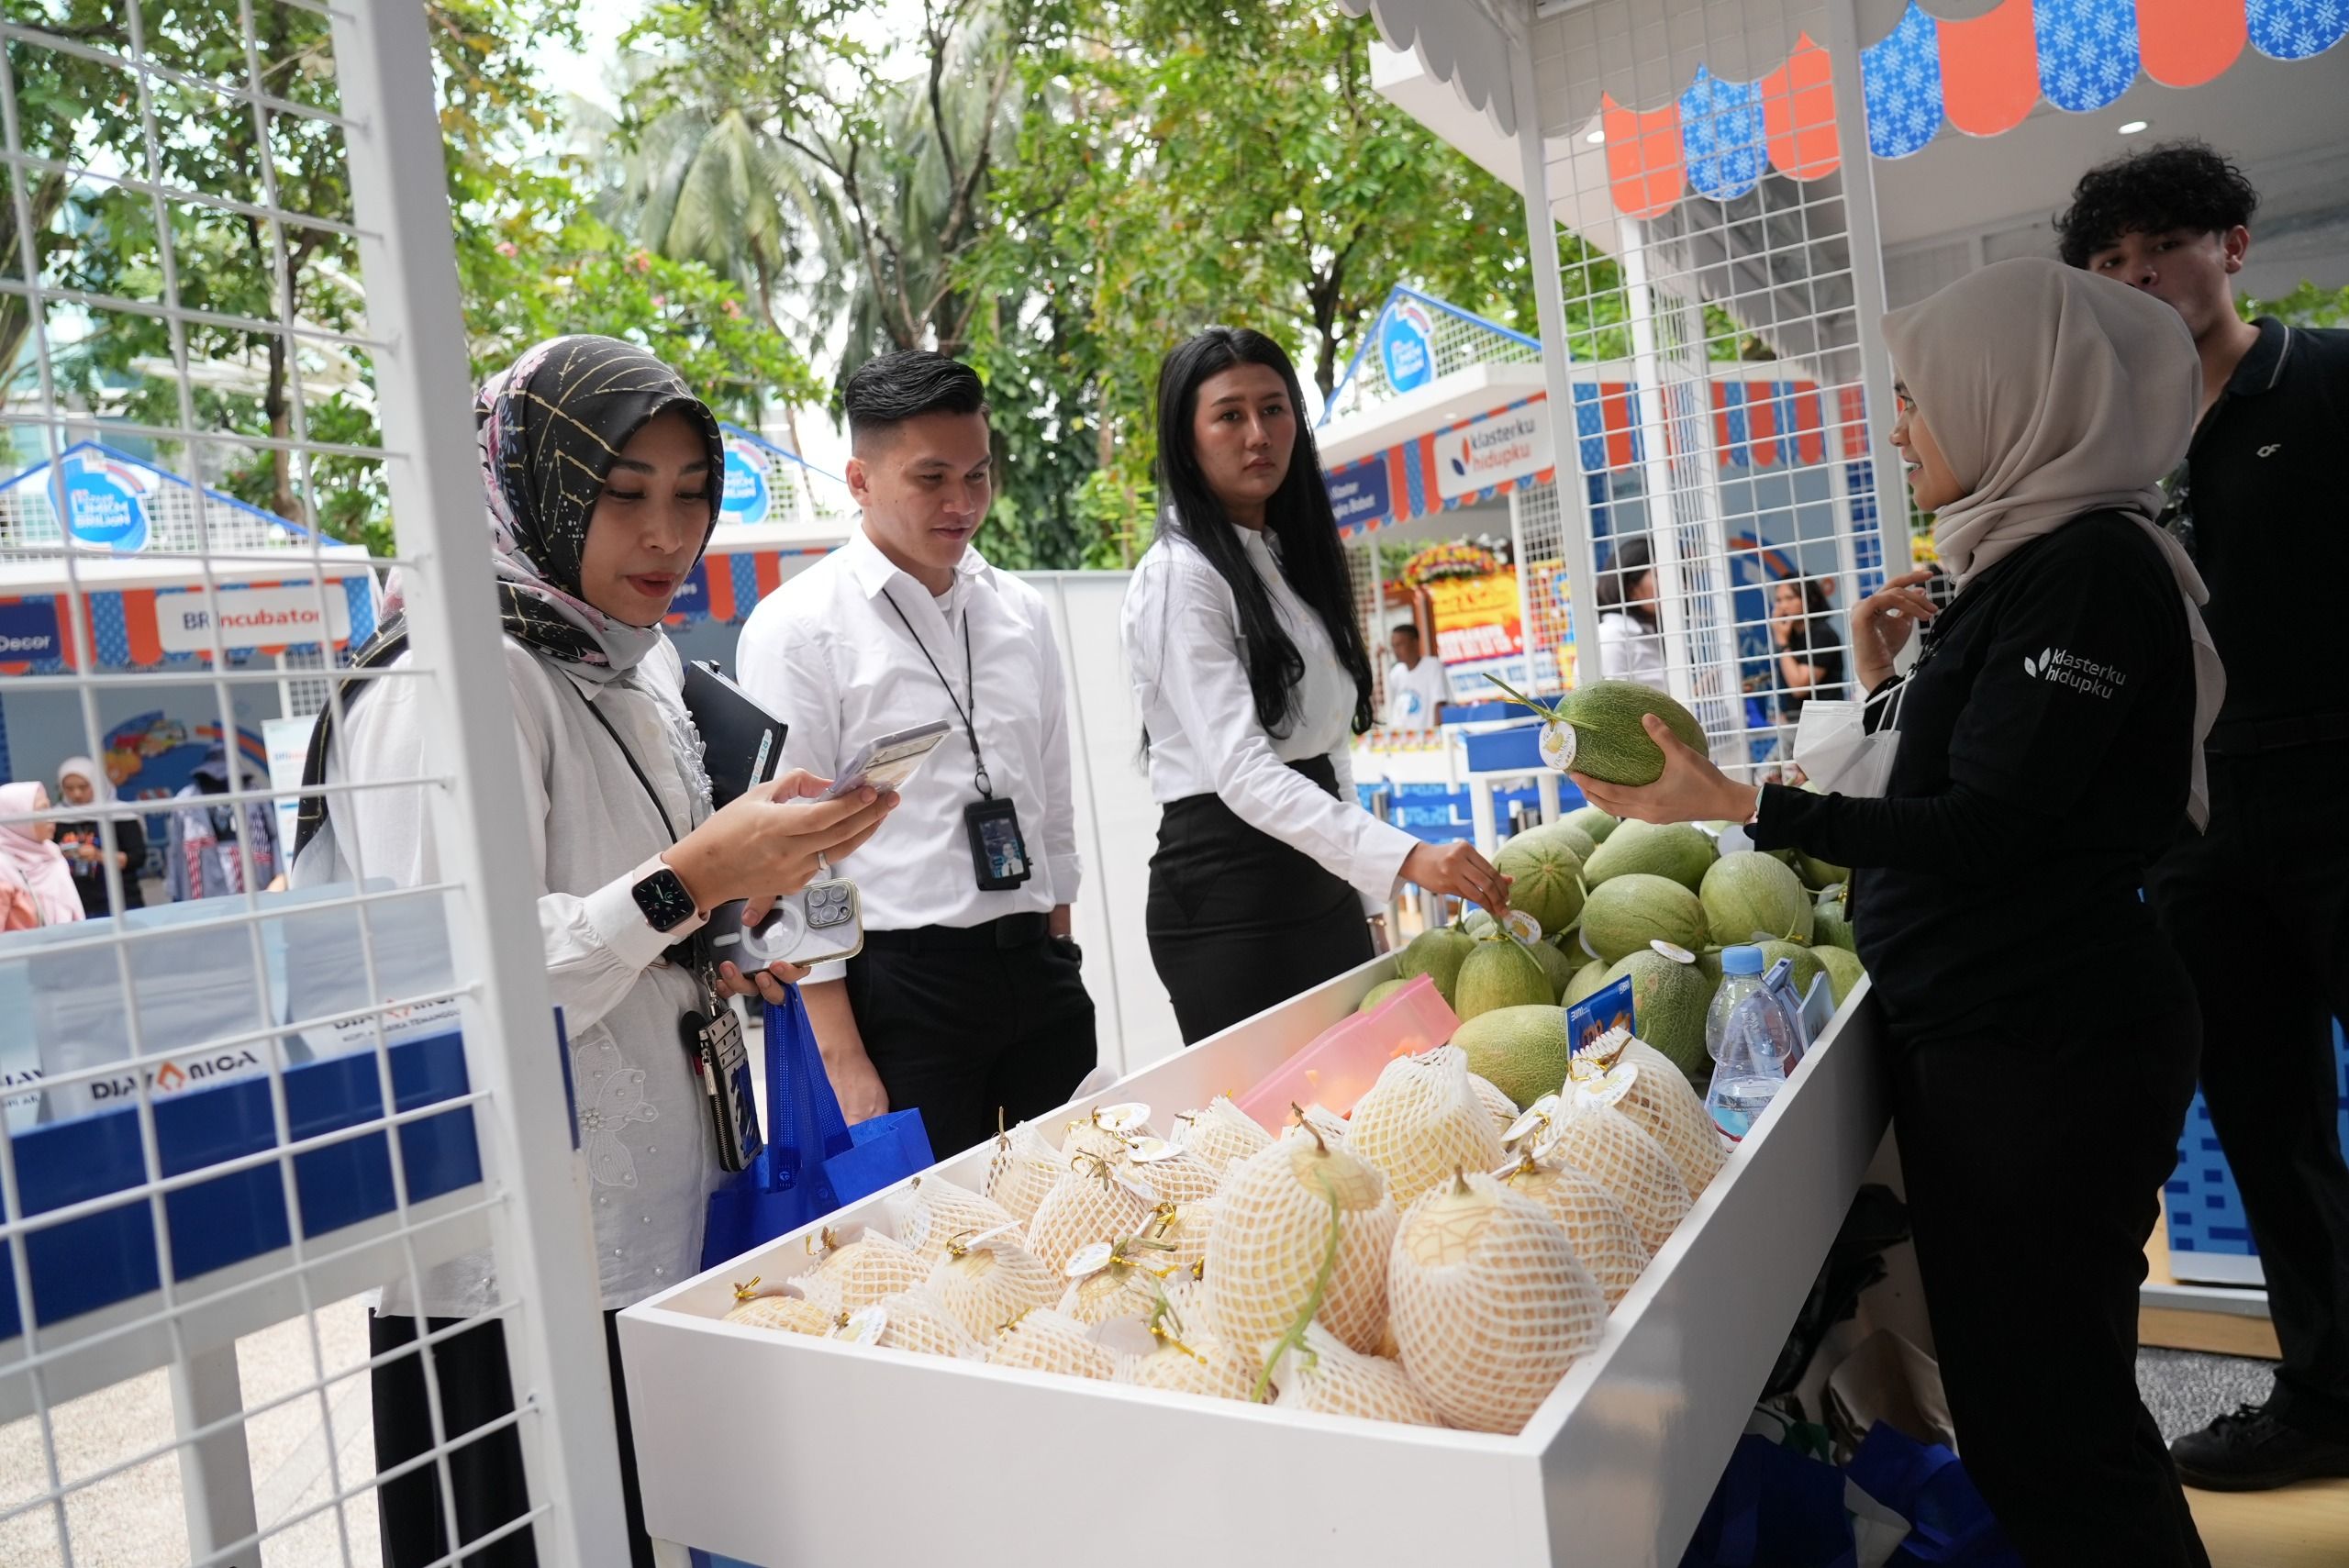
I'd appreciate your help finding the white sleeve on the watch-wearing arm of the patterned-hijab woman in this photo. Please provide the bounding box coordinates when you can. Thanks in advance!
[328,648,700,1038]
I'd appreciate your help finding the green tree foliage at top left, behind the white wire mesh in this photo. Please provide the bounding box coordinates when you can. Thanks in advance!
[0,0,810,550]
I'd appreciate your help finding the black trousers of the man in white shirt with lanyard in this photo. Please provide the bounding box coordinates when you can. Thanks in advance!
[848,916,1099,1160]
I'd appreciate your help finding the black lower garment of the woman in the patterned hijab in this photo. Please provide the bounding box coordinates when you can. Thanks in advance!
[366,1312,653,1568]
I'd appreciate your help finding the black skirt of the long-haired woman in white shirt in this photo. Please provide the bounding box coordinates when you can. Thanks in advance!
[1144,758,1375,1044]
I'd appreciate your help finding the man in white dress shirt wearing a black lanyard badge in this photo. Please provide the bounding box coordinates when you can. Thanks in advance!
[735,350,1097,1157]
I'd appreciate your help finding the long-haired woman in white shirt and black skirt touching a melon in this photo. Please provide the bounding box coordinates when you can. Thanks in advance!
[1125,327,1508,1044]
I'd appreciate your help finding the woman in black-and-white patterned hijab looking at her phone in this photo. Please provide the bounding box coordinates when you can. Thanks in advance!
[294,336,895,1568]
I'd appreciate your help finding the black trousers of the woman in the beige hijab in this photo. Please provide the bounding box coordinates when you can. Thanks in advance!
[1891,972,2210,1568]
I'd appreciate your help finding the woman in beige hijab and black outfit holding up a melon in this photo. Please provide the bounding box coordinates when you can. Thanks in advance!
[1578,261,2217,1568]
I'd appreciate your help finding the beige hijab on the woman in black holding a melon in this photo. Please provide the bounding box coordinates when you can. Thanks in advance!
[1884,258,2227,827]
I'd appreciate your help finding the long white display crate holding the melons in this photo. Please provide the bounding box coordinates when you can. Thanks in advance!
[620,960,1887,1568]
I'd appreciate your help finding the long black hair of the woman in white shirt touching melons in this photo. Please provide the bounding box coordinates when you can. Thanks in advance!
[1158,327,1369,735]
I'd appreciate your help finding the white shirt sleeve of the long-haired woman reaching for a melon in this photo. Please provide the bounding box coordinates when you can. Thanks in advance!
[1144,561,1419,908]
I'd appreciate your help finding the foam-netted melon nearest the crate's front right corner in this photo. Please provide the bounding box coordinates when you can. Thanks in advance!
[1388,1176,1607,1434]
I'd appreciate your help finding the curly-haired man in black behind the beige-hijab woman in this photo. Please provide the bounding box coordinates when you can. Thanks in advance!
[2055,141,2349,1491]
